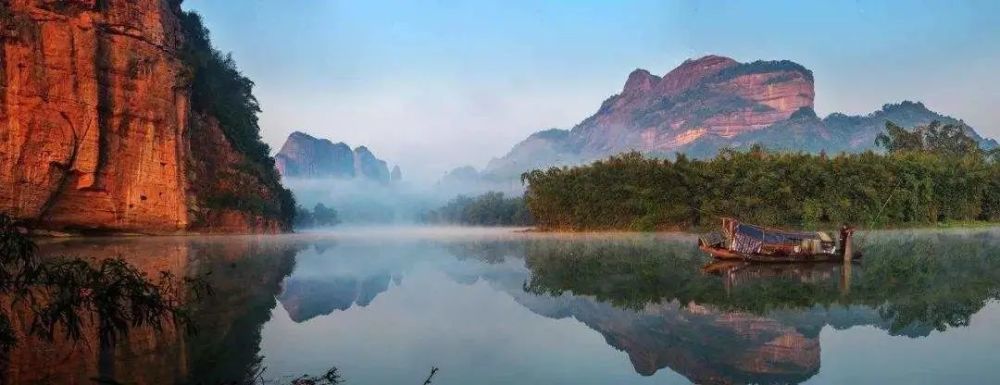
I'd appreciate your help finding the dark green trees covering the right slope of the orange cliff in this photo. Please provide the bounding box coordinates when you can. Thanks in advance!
[180,11,295,224]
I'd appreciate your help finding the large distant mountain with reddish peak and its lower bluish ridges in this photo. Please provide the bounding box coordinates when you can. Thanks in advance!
[483,56,997,179]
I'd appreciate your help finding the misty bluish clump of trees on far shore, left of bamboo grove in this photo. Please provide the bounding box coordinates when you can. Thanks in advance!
[421,192,533,226]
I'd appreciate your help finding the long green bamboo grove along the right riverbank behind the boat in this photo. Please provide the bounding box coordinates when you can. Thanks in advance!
[522,123,1000,230]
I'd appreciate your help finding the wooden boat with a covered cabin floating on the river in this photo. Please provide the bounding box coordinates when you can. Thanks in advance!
[698,218,861,263]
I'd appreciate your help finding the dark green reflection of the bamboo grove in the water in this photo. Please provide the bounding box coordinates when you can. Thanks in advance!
[524,230,1000,336]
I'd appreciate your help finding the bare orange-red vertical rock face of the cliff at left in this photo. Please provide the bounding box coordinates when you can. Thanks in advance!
[0,0,292,233]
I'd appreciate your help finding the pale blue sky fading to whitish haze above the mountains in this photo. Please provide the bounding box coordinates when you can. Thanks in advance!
[182,0,1000,182]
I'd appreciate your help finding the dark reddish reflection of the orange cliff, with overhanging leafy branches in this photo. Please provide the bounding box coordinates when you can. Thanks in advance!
[0,214,301,385]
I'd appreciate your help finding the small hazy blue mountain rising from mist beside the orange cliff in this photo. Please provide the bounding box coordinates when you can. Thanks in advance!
[274,131,402,182]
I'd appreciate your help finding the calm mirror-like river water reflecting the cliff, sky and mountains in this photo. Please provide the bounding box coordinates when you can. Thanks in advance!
[6,229,1000,384]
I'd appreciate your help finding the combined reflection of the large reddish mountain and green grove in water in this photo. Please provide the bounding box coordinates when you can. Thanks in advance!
[453,233,1000,384]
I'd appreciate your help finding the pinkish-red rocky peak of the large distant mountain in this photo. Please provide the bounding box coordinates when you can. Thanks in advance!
[573,56,814,156]
